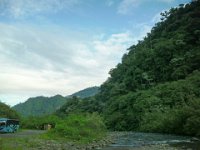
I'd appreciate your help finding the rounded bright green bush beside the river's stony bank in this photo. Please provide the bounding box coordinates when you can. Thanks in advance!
[47,113,106,143]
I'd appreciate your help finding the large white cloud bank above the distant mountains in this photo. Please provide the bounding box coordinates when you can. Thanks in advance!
[0,23,138,105]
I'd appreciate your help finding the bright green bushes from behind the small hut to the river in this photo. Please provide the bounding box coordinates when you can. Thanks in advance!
[21,113,106,143]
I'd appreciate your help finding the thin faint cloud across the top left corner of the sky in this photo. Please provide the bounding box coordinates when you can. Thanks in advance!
[0,0,80,18]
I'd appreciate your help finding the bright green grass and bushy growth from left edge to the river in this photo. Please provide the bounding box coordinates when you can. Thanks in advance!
[0,114,106,150]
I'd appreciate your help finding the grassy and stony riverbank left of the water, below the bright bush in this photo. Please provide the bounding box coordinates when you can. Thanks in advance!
[0,130,115,150]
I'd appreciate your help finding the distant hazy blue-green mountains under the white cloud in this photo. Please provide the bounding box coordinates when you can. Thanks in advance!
[13,87,99,116]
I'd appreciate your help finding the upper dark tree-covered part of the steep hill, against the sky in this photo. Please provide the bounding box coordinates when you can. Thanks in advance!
[101,1,200,100]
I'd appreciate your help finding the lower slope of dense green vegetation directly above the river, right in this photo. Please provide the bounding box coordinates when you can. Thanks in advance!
[104,72,200,135]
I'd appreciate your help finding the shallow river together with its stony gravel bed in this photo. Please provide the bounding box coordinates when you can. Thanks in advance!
[27,132,200,150]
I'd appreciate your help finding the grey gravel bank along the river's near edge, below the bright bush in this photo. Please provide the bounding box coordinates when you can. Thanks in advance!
[28,132,183,150]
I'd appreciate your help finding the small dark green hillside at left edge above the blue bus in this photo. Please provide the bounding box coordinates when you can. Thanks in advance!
[0,102,19,119]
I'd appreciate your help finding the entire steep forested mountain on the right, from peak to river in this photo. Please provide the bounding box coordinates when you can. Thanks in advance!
[57,0,200,136]
